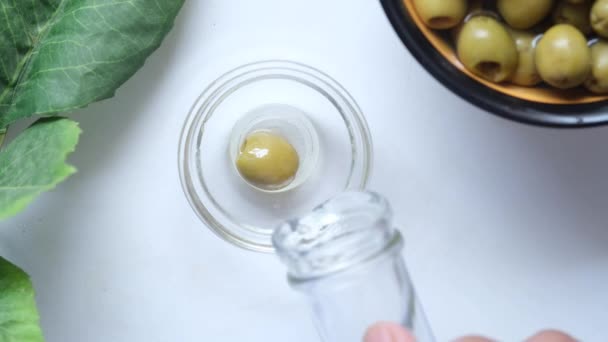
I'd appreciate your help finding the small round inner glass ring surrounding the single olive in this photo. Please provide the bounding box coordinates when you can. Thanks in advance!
[230,104,319,192]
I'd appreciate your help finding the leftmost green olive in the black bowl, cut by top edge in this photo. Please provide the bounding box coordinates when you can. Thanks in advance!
[414,0,467,30]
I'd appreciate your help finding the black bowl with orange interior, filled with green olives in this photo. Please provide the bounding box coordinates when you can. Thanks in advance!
[380,0,608,127]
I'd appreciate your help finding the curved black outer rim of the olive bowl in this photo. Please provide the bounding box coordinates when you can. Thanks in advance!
[380,0,608,128]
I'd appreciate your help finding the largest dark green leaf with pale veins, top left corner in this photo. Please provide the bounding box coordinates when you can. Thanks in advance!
[0,0,184,128]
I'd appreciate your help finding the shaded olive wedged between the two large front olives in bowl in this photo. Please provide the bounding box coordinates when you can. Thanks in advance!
[510,30,541,86]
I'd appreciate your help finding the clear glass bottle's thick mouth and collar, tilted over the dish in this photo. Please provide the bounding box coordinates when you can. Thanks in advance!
[273,192,402,283]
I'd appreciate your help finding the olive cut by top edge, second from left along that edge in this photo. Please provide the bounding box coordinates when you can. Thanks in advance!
[496,0,553,29]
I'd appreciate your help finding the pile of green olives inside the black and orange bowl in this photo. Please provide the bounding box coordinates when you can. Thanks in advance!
[413,0,608,93]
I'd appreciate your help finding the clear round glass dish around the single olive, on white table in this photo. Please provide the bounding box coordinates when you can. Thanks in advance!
[178,61,372,252]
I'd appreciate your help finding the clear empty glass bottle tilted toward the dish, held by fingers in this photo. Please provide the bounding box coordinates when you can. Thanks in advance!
[273,192,434,342]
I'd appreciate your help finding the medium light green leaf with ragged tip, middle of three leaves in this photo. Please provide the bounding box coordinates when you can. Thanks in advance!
[0,118,80,219]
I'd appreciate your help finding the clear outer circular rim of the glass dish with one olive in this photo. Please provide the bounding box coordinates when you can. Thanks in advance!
[178,60,373,253]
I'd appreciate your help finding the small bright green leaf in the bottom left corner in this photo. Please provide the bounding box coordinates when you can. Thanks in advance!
[0,257,44,342]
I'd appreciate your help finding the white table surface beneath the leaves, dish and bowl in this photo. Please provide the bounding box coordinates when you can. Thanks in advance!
[0,0,608,342]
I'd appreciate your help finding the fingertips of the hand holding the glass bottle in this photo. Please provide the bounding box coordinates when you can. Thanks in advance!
[364,322,576,342]
